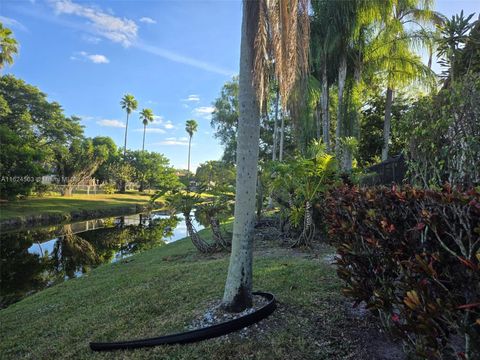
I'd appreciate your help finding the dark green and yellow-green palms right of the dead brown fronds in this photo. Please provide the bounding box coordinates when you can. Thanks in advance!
[311,0,444,166]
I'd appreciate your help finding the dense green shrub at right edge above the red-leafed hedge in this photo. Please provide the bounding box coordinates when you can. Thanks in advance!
[400,74,480,187]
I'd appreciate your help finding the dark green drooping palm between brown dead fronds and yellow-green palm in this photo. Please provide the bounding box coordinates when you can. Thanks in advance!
[312,0,378,165]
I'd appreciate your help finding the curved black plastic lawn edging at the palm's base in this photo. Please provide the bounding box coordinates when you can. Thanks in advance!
[90,292,277,351]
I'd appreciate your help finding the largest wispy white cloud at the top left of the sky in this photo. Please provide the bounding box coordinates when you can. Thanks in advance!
[50,0,138,47]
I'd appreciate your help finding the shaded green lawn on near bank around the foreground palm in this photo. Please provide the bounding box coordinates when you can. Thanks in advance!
[0,224,382,360]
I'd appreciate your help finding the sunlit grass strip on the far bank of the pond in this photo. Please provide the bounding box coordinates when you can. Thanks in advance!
[0,193,155,220]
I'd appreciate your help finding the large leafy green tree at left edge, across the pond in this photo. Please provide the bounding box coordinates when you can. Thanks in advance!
[0,75,83,198]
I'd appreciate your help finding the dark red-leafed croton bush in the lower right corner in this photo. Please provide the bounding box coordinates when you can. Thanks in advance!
[327,186,480,360]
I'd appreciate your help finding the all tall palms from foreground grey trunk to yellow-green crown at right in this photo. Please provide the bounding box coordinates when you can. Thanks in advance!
[223,0,448,311]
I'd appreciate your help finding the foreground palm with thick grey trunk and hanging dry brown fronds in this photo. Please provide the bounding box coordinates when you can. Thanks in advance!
[222,0,309,312]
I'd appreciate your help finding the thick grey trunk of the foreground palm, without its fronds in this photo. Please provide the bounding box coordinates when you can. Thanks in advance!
[223,0,260,312]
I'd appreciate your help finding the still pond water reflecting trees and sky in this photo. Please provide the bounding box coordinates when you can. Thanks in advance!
[0,212,203,309]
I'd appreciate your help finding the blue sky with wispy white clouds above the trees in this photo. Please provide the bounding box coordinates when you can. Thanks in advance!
[0,0,480,168]
